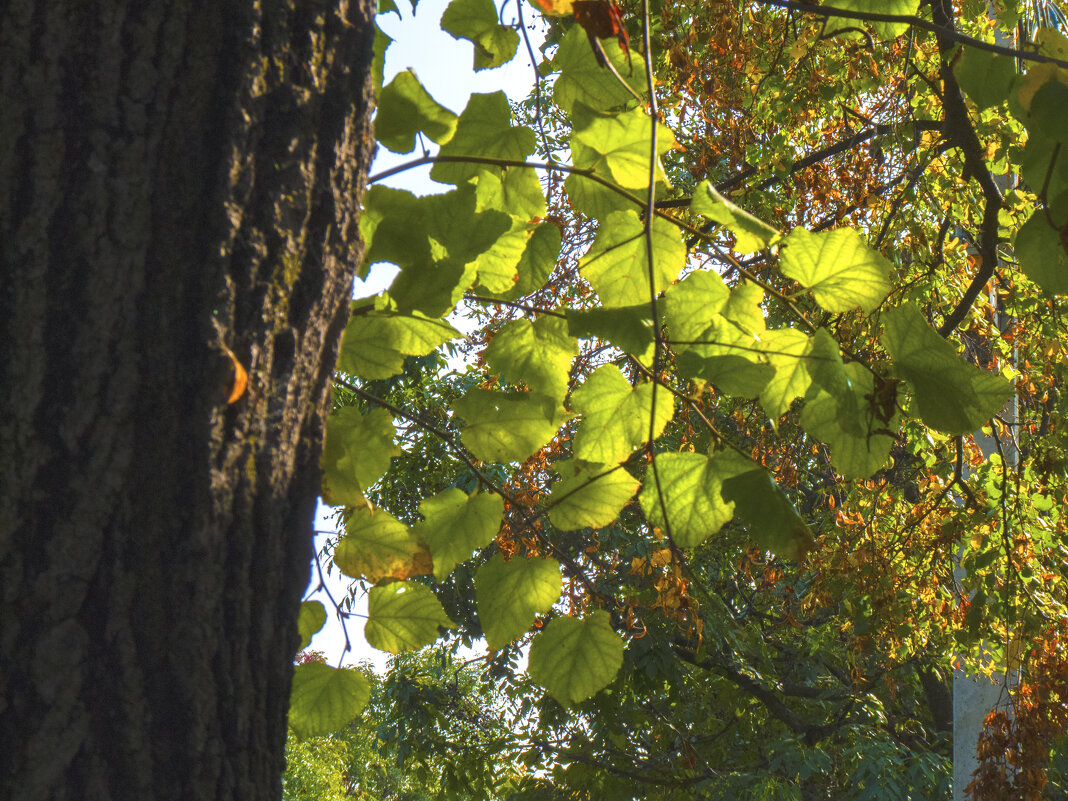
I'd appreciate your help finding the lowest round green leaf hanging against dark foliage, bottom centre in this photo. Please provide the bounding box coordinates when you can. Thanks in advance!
[529,610,624,706]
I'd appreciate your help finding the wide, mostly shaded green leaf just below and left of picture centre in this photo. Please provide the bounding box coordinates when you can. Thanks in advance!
[453,390,565,462]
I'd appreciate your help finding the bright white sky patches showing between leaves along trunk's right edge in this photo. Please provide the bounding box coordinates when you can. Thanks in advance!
[309,0,543,671]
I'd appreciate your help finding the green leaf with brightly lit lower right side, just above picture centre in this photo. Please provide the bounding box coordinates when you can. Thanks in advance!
[485,315,579,401]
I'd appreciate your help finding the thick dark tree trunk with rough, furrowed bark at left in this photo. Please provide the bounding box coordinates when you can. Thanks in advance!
[0,0,374,801]
